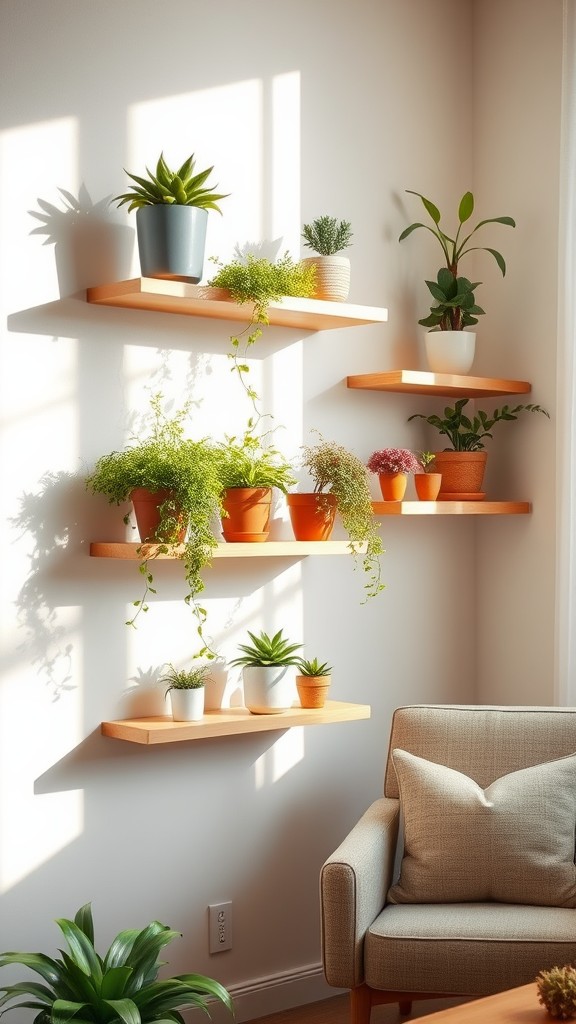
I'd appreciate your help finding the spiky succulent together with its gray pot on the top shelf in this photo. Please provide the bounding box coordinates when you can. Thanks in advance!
[113,153,228,284]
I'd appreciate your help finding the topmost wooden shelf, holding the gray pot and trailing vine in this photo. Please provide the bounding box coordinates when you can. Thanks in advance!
[86,278,388,331]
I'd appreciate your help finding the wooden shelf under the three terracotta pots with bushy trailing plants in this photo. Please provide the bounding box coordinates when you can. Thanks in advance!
[90,541,366,561]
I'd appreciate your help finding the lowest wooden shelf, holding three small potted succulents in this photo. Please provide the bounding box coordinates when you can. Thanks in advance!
[100,700,371,745]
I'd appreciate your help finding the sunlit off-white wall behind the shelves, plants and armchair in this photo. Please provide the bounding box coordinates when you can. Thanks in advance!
[0,0,561,1020]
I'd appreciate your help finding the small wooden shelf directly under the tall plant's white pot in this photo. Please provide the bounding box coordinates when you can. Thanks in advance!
[346,370,532,398]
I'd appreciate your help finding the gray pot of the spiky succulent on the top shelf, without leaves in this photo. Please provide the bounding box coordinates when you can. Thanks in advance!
[136,204,208,284]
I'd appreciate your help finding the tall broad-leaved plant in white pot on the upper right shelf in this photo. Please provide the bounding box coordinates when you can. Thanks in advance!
[399,188,516,374]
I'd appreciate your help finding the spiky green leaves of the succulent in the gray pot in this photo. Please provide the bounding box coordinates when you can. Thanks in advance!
[113,153,228,213]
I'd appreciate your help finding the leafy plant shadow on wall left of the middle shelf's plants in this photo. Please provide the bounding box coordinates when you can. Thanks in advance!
[8,472,87,700]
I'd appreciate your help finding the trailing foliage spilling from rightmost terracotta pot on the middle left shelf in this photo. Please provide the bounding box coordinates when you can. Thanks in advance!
[301,431,384,599]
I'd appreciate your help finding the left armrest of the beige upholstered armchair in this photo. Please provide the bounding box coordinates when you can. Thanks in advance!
[320,797,400,988]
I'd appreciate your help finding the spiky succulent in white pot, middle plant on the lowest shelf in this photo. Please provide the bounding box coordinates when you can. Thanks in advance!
[231,630,302,715]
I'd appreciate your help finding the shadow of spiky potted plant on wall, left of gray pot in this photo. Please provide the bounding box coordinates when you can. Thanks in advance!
[28,185,134,298]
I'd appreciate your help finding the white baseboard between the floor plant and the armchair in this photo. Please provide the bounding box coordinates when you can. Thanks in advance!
[187,964,344,1024]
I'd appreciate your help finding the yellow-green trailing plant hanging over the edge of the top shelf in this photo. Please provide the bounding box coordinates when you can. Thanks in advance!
[208,252,316,419]
